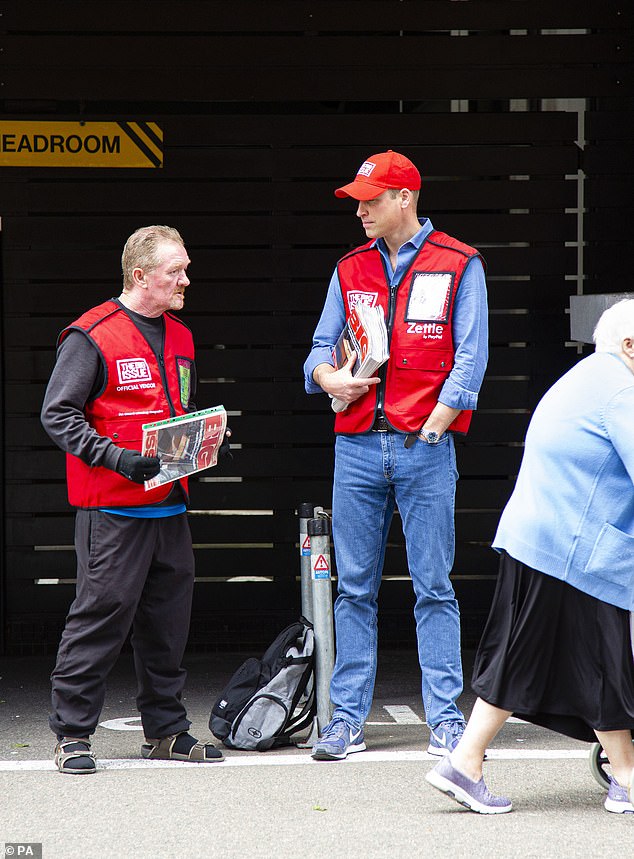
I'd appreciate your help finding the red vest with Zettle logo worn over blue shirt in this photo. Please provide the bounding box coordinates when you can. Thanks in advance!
[335,231,479,433]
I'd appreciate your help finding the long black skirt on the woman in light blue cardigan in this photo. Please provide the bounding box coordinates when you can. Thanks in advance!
[472,554,634,742]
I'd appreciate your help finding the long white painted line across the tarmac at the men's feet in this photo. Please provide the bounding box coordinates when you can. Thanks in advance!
[0,749,590,772]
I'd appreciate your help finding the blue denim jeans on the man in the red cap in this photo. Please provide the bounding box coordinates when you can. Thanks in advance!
[330,432,463,728]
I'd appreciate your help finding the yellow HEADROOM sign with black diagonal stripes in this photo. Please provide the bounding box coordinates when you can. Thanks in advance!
[0,120,163,167]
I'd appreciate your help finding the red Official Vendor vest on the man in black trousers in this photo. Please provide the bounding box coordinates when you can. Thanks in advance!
[58,300,194,507]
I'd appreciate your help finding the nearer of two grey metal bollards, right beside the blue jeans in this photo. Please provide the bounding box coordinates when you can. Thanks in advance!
[308,515,335,731]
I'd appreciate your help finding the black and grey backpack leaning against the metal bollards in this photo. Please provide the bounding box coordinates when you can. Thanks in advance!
[209,617,317,752]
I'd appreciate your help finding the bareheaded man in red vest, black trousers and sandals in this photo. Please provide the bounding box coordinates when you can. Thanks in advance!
[42,226,222,774]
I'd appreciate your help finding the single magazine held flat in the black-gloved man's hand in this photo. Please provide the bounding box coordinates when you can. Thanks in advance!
[142,406,227,490]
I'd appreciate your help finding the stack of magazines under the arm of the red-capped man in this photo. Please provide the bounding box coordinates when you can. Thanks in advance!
[331,304,390,412]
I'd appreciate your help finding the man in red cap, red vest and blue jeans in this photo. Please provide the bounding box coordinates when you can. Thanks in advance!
[304,150,488,760]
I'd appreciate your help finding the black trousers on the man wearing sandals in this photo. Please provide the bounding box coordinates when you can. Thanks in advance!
[49,510,194,738]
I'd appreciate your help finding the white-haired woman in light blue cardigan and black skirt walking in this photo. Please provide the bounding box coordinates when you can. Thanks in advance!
[427,299,634,814]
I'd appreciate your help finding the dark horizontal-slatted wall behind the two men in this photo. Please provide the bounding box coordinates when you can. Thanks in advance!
[0,0,632,652]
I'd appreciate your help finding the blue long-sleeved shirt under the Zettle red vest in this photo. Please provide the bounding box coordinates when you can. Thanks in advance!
[304,218,489,409]
